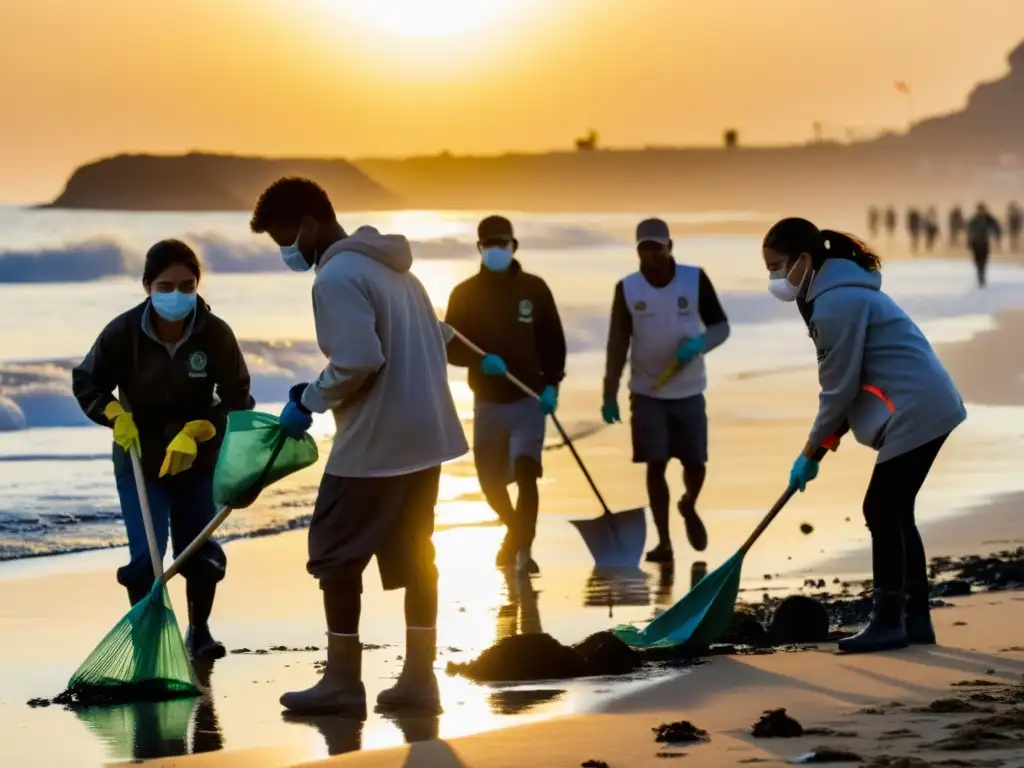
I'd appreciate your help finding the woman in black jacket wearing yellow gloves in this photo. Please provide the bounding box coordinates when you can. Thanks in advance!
[72,240,254,658]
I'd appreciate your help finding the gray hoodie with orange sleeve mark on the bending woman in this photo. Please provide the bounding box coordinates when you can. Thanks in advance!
[807,258,967,462]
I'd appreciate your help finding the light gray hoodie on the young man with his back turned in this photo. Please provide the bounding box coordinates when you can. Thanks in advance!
[302,226,469,477]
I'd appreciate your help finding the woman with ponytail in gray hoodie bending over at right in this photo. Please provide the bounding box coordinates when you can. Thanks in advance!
[763,218,967,652]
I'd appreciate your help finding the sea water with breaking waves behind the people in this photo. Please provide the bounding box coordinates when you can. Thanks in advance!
[0,208,1024,559]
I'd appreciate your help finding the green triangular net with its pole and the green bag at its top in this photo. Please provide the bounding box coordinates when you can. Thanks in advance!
[53,411,317,709]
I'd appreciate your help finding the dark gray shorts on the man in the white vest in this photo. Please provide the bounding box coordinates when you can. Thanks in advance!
[630,394,708,467]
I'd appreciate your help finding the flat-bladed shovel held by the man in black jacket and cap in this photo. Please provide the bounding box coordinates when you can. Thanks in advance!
[452,328,647,568]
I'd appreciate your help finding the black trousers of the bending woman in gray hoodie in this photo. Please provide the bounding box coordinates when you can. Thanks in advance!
[864,433,949,592]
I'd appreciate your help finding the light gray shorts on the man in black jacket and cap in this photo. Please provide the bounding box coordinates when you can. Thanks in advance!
[473,397,547,484]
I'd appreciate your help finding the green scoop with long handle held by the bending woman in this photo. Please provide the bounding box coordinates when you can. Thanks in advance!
[612,438,838,648]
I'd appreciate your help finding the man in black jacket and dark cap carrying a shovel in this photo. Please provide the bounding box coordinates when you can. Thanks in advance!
[444,216,565,573]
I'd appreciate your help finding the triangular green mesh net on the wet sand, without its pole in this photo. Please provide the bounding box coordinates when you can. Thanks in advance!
[54,584,200,707]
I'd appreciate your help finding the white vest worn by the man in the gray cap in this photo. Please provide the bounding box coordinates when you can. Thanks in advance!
[623,264,708,400]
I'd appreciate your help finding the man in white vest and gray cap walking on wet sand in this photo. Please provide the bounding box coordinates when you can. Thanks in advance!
[601,219,729,563]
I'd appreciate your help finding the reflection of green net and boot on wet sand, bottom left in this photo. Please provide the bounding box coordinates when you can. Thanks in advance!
[86,660,224,761]
